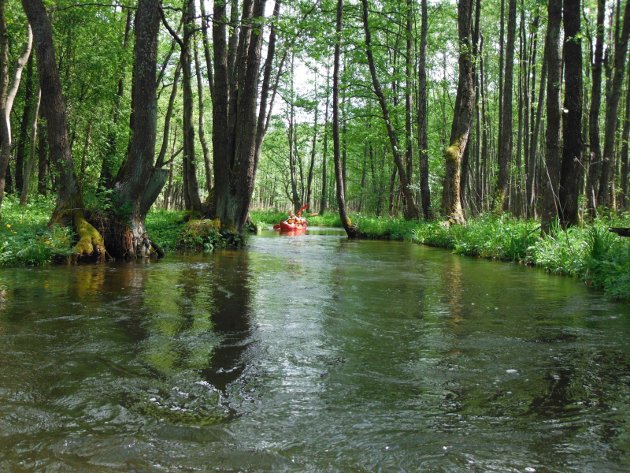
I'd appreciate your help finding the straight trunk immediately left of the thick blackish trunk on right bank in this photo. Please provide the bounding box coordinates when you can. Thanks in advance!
[541,0,562,233]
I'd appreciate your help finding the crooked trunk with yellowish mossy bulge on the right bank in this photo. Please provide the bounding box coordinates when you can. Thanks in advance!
[442,0,475,224]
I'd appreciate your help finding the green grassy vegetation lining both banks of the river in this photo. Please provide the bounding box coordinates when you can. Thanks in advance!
[0,196,630,300]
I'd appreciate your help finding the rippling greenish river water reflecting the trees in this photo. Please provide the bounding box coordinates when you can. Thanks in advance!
[0,229,630,472]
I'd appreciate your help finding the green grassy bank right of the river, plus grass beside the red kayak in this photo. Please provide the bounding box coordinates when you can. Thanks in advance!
[252,212,630,300]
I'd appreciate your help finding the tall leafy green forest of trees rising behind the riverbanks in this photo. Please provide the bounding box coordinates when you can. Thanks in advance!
[0,0,630,296]
